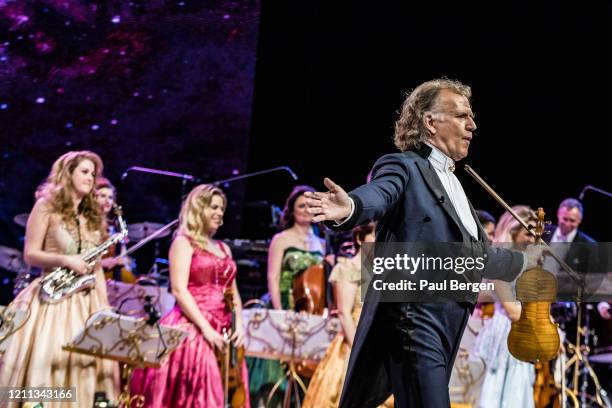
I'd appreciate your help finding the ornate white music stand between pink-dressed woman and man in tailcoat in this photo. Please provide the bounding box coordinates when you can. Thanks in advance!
[243,309,340,408]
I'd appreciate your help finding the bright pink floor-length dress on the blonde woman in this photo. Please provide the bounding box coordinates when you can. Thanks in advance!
[131,244,250,408]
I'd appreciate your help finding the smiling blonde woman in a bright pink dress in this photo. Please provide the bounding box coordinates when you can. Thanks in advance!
[132,184,250,408]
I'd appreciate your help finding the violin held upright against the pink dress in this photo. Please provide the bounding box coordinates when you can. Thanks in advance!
[216,287,248,408]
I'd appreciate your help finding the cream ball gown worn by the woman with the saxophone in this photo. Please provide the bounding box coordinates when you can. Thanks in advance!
[0,214,119,408]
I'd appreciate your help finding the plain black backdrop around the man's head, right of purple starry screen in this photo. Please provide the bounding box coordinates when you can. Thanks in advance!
[249,1,612,241]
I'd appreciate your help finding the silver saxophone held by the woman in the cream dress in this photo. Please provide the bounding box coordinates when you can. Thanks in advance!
[39,206,128,303]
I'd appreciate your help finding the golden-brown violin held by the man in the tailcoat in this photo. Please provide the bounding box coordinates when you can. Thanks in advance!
[508,208,561,362]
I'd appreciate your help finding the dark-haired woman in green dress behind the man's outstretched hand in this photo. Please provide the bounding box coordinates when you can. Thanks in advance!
[248,185,325,405]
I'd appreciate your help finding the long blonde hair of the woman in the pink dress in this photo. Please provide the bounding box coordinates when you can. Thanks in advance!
[176,184,227,248]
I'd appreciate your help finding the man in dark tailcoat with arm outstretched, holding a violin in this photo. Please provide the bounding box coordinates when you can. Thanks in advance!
[306,79,541,408]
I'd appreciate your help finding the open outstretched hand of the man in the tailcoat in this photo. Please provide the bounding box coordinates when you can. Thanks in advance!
[304,178,352,222]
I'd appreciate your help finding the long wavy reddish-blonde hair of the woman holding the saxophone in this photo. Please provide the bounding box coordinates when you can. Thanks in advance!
[35,150,104,231]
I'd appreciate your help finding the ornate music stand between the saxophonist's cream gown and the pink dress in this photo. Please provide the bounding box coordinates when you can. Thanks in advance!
[63,309,187,407]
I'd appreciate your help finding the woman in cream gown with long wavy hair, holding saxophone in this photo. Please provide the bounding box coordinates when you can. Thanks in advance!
[0,151,119,407]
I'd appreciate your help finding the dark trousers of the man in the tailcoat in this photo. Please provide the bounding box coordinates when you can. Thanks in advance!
[377,302,473,408]
